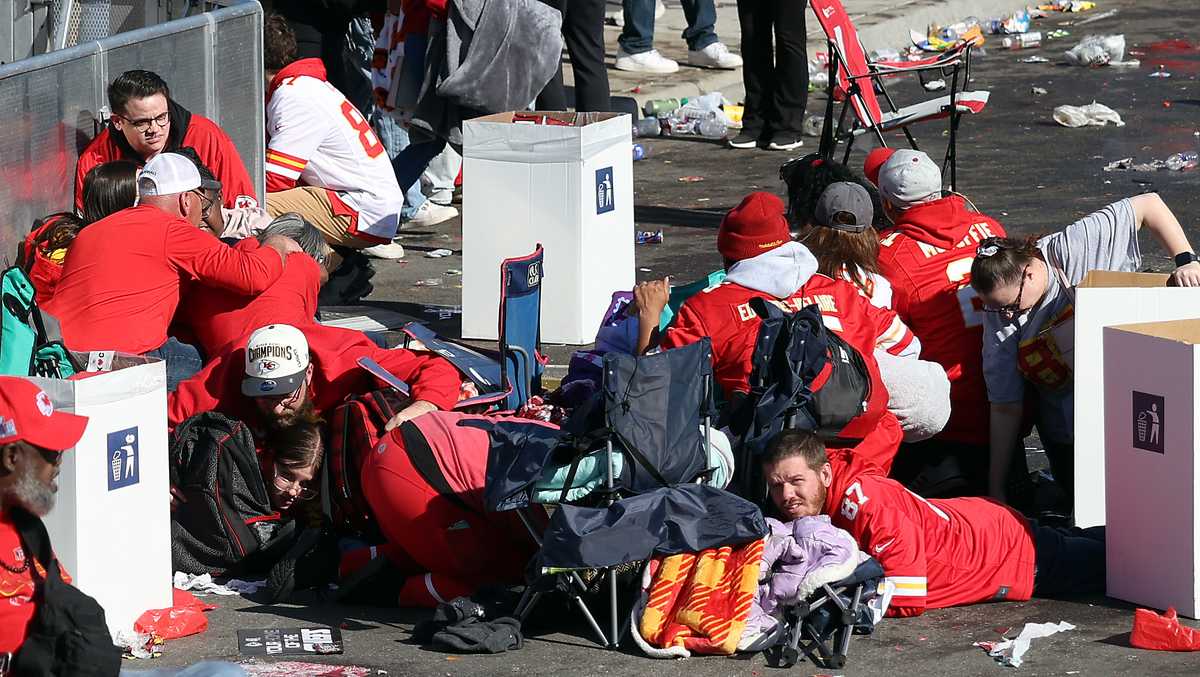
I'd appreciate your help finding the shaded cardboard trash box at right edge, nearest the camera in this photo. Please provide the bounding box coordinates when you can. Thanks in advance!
[1097,319,1200,618]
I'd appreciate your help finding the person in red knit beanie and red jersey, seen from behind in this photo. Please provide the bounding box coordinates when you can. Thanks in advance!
[635,192,912,468]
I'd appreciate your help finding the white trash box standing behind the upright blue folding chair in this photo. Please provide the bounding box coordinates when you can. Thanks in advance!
[462,113,634,346]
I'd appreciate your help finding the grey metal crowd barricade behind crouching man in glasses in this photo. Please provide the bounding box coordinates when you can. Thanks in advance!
[0,0,265,263]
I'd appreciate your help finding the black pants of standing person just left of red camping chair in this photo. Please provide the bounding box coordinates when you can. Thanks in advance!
[738,0,809,138]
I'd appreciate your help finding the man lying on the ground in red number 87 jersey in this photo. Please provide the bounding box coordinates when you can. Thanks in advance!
[762,430,1105,616]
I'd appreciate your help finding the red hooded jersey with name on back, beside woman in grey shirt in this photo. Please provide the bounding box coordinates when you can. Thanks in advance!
[880,196,1004,445]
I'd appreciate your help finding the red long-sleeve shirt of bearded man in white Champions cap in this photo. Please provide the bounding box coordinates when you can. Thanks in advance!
[167,323,461,427]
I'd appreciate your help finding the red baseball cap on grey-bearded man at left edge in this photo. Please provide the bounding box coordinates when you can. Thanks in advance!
[0,376,88,451]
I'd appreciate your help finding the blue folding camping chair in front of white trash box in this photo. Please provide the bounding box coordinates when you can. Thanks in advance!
[401,244,545,411]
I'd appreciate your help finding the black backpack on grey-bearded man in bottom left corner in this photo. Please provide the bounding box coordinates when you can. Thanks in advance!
[11,508,121,677]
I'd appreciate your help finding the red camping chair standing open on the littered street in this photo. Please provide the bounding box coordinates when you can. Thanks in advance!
[809,0,989,191]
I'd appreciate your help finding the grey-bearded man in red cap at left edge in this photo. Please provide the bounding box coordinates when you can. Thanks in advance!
[0,376,88,657]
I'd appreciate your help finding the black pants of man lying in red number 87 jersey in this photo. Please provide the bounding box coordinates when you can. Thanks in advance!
[1030,520,1105,597]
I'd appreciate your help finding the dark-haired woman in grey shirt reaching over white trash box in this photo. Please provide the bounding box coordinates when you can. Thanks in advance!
[971,193,1200,501]
